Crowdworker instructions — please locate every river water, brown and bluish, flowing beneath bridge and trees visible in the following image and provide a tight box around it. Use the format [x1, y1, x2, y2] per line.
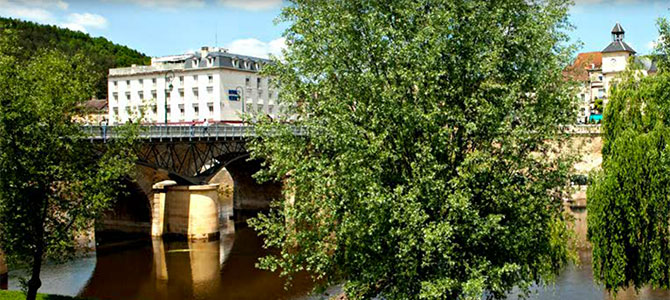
[3, 225, 670, 300]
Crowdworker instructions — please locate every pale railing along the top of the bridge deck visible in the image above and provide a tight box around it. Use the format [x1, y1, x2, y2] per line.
[82, 124, 306, 140]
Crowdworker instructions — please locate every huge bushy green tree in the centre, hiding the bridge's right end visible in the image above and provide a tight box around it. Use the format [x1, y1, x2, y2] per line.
[250, 0, 576, 299]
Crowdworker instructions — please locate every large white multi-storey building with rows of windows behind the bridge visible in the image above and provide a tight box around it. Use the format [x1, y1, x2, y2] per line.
[108, 47, 279, 124]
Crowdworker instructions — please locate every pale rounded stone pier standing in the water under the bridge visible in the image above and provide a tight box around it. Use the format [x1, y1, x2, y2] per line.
[151, 181, 219, 239]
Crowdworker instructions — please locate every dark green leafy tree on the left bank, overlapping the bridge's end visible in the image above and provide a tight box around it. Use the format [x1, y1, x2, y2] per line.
[0, 35, 137, 299]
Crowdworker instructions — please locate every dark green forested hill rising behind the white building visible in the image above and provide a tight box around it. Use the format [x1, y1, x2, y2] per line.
[0, 17, 151, 100]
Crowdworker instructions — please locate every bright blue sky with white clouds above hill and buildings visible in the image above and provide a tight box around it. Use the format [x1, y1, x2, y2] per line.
[0, 0, 670, 57]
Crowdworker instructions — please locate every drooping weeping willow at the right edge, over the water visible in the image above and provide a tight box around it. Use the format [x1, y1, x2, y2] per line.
[587, 20, 670, 293]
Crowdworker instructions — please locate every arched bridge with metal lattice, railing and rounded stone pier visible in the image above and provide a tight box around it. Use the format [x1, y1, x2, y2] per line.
[84, 124, 302, 243]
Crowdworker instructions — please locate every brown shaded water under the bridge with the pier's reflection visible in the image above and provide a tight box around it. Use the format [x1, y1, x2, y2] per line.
[75, 227, 311, 299]
